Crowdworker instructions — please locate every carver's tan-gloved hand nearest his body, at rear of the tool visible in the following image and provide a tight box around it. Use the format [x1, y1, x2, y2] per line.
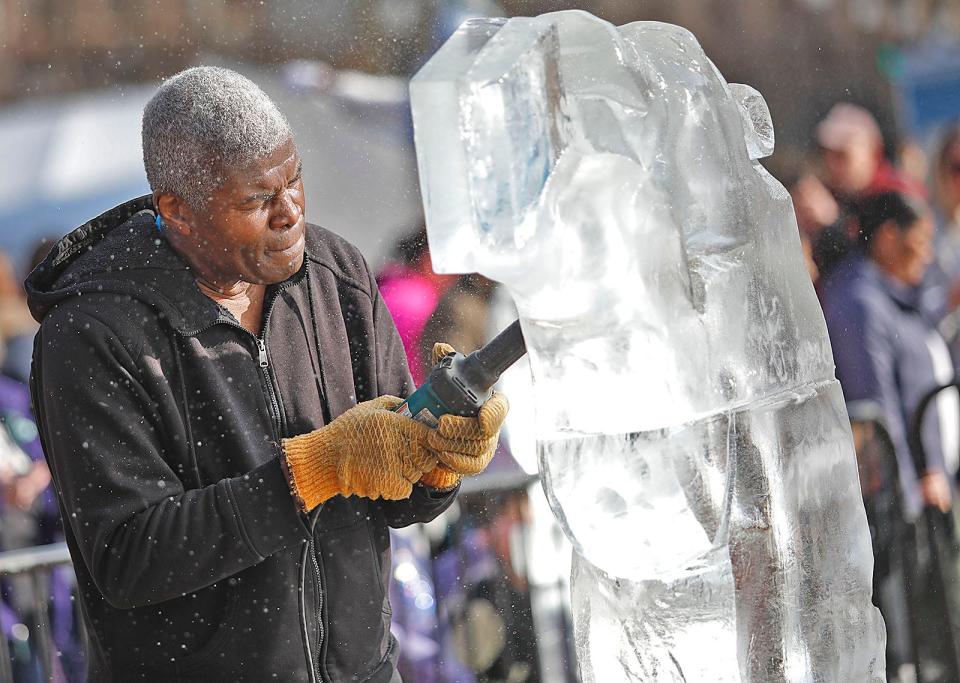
[283, 396, 437, 512]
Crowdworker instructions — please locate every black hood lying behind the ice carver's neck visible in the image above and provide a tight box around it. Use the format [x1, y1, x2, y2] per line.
[24, 195, 220, 333]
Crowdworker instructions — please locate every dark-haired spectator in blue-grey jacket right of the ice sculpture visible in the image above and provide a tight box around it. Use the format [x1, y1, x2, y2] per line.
[823, 193, 958, 518]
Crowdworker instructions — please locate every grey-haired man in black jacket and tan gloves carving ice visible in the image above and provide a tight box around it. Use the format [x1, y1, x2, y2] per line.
[27, 67, 506, 683]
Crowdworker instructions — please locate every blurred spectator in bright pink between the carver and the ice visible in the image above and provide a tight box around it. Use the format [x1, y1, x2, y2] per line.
[377, 224, 456, 385]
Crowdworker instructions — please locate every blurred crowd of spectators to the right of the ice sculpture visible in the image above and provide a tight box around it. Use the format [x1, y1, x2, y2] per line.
[790, 103, 960, 682]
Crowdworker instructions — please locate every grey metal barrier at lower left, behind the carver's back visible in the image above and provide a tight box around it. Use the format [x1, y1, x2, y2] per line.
[0, 543, 70, 683]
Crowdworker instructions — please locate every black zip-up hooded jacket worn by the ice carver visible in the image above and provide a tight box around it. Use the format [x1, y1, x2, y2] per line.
[27, 197, 454, 683]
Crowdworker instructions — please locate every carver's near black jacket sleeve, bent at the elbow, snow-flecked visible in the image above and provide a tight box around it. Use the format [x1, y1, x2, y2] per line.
[31, 306, 309, 608]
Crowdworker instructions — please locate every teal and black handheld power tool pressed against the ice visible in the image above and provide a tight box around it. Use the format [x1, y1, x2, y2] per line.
[396, 320, 527, 428]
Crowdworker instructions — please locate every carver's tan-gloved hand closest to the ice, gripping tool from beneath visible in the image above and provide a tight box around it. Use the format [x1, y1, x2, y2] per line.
[420, 343, 510, 489]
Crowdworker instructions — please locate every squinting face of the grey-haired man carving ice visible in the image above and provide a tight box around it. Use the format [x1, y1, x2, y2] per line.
[178, 140, 305, 287]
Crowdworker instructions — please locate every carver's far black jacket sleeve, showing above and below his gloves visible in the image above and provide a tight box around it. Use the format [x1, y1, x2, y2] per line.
[370, 270, 460, 528]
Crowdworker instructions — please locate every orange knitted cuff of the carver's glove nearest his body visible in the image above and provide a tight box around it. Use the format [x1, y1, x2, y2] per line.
[283, 429, 340, 512]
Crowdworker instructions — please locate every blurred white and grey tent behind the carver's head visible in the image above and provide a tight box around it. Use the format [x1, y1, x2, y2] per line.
[0, 58, 422, 267]
